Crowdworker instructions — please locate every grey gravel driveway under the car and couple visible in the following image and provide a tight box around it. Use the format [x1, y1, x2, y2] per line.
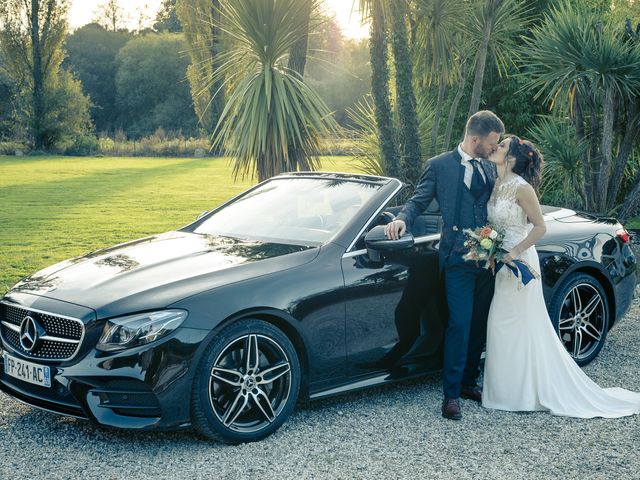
[0, 289, 640, 479]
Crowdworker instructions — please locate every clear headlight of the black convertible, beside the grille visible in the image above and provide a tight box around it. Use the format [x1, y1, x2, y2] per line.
[96, 310, 188, 352]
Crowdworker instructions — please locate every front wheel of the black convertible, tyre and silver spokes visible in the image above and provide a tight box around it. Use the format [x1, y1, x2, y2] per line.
[191, 319, 300, 444]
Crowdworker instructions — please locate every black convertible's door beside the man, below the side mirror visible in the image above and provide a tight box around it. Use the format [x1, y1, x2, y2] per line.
[342, 201, 444, 377]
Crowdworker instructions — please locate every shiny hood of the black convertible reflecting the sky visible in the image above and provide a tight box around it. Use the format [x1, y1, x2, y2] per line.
[6, 231, 319, 318]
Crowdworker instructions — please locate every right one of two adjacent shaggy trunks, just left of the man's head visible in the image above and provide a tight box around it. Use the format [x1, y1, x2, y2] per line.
[391, 2, 422, 185]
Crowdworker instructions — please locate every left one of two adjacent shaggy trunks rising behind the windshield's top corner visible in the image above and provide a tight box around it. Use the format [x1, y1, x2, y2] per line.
[369, 0, 400, 177]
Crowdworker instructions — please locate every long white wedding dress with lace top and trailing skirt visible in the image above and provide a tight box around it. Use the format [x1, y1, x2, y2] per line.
[482, 176, 640, 418]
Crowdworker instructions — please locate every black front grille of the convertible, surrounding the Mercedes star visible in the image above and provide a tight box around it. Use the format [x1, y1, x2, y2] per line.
[0, 303, 84, 360]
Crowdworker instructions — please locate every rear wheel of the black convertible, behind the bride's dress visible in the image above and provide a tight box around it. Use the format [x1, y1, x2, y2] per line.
[549, 273, 609, 366]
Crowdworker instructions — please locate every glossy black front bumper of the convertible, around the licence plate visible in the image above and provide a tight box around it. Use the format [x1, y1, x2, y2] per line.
[0, 328, 209, 430]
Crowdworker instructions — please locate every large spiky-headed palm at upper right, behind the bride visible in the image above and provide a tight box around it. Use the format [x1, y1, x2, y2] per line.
[523, 1, 640, 213]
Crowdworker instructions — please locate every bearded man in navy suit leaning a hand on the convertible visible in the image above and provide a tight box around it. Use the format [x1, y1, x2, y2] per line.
[385, 110, 504, 420]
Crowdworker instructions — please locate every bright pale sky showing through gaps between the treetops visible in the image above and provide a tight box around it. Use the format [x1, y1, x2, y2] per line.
[69, 0, 369, 38]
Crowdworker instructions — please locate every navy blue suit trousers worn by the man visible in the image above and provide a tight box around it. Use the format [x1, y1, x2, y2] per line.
[442, 259, 495, 398]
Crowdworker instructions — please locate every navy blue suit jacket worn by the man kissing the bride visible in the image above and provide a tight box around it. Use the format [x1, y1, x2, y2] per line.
[397, 149, 496, 266]
